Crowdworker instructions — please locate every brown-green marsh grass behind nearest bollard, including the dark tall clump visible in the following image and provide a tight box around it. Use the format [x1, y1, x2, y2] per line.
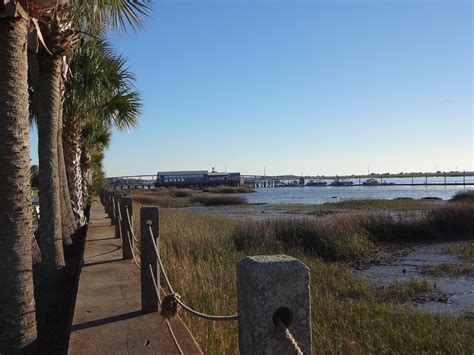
[124, 199, 474, 354]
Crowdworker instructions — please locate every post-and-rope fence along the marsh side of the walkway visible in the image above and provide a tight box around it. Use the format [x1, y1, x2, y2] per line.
[100, 189, 312, 354]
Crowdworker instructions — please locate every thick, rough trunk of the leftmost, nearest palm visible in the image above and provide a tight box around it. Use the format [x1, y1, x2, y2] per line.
[0, 17, 36, 353]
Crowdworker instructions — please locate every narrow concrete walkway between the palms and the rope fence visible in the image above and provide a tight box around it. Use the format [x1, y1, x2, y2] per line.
[69, 202, 202, 355]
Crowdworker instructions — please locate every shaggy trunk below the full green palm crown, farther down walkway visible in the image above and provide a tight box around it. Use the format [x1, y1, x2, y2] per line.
[63, 118, 86, 227]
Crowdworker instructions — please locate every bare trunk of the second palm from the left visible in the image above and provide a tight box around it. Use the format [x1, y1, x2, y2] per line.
[35, 53, 65, 273]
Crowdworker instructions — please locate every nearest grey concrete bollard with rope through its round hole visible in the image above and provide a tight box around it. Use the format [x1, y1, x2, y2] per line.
[237, 255, 311, 355]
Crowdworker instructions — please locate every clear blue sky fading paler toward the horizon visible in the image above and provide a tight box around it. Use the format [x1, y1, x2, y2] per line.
[32, 0, 474, 176]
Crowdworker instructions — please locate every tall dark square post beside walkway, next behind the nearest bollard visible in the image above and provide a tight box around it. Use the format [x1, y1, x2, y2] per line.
[140, 207, 160, 312]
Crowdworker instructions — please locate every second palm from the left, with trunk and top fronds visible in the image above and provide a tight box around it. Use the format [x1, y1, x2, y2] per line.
[35, 0, 147, 272]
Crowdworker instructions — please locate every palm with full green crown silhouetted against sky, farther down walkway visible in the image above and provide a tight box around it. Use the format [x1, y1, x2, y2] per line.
[63, 38, 141, 216]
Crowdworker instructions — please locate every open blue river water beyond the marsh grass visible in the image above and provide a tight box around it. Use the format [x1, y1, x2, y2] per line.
[245, 185, 474, 205]
